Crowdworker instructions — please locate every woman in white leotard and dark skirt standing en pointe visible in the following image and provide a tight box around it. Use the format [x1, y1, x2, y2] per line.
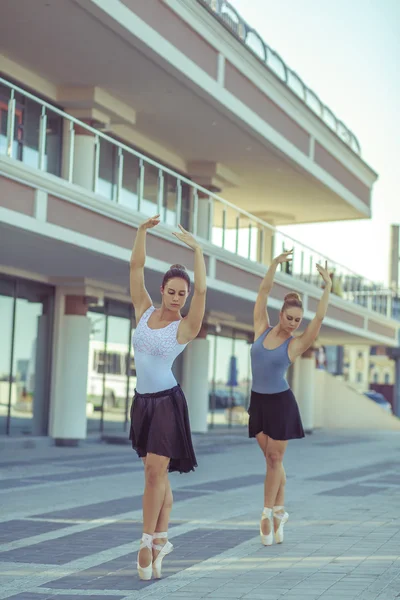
[130, 215, 206, 580]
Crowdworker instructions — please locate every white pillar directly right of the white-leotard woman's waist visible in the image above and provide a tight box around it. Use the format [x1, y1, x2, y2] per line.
[182, 338, 209, 433]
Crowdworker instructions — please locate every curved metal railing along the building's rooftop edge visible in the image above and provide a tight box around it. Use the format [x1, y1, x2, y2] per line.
[198, 0, 361, 155]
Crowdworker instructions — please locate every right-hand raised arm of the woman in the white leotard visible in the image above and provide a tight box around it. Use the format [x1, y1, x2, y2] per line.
[174, 225, 207, 344]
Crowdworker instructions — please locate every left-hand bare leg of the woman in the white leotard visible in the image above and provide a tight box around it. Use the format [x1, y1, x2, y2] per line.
[139, 453, 170, 567]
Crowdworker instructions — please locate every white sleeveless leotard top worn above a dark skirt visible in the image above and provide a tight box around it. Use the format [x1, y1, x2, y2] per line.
[132, 306, 187, 394]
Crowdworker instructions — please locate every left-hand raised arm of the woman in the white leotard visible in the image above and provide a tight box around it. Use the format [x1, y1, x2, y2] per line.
[130, 215, 160, 323]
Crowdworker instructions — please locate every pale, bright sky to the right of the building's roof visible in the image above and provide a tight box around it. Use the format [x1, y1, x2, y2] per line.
[230, 0, 400, 284]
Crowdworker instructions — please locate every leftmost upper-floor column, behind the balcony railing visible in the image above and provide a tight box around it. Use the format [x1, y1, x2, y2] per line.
[62, 120, 95, 191]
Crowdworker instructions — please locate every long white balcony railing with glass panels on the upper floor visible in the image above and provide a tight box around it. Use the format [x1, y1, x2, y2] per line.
[0, 78, 399, 317]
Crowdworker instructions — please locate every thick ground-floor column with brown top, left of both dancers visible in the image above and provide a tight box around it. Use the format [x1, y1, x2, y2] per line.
[49, 296, 90, 446]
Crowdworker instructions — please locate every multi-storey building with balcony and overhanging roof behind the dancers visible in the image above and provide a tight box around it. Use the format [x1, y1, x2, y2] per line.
[0, 0, 400, 443]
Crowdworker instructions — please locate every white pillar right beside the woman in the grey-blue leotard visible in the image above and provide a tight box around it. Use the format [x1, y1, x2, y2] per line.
[294, 355, 315, 433]
